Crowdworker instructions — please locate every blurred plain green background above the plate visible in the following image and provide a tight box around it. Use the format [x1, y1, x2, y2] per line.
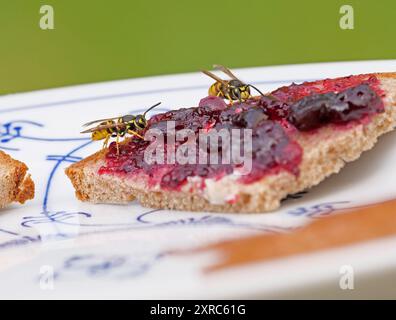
[0, 0, 396, 94]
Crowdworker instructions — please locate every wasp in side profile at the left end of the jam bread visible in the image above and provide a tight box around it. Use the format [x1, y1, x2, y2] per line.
[81, 102, 161, 154]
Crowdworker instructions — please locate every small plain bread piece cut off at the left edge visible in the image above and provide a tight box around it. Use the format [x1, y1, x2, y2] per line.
[0, 151, 34, 208]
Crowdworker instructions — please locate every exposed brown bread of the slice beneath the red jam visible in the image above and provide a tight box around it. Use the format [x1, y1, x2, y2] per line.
[66, 73, 396, 212]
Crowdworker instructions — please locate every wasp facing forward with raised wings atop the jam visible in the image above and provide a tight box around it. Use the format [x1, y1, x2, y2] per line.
[202, 64, 264, 104]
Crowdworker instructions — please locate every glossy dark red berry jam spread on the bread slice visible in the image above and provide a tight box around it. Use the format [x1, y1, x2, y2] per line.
[99, 75, 384, 190]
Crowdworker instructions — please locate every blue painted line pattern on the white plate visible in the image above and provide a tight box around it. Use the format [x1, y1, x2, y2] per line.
[0, 75, 348, 255]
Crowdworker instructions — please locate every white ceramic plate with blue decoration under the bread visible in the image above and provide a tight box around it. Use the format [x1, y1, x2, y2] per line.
[0, 60, 396, 299]
